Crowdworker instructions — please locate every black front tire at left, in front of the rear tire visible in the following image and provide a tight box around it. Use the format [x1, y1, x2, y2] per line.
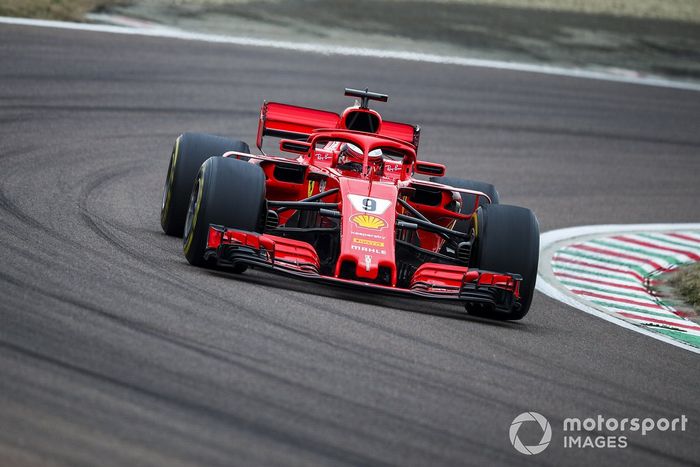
[183, 157, 265, 272]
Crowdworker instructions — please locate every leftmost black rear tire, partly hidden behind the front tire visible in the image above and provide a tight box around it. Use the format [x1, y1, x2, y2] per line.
[160, 133, 250, 237]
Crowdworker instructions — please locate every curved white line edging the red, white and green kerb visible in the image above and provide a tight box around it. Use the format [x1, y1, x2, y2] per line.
[537, 224, 700, 354]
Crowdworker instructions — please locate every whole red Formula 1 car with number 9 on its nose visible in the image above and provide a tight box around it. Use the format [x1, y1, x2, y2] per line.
[161, 89, 539, 319]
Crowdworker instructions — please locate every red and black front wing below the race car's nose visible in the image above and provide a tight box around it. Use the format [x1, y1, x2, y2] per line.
[204, 225, 522, 312]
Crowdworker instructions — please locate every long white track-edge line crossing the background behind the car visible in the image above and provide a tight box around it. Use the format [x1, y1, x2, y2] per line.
[0, 16, 700, 91]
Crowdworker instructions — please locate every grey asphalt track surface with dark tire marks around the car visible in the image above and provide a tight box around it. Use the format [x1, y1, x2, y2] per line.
[0, 25, 700, 466]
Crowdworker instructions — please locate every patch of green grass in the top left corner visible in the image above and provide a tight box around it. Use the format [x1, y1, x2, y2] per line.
[0, 0, 128, 21]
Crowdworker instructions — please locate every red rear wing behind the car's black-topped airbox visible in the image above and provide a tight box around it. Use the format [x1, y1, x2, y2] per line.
[256, 102, 420, 151]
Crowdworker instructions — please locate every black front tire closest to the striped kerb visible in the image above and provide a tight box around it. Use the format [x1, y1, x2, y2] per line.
[467, 204, 540, 320]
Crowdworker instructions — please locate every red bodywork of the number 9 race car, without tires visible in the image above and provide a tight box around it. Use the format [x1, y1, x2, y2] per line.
[205, 96, 520, 309]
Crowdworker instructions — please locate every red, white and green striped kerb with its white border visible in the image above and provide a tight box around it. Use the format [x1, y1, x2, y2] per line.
[537, 224, 700, 353]
